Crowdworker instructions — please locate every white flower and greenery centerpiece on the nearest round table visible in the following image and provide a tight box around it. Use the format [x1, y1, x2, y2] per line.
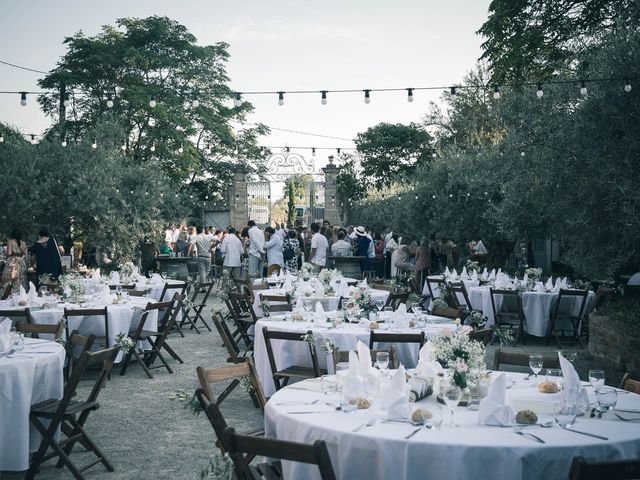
[430, 332, 486, 390]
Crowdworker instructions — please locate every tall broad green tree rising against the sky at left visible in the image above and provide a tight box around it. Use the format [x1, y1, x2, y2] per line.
[39, 16, 268, 193]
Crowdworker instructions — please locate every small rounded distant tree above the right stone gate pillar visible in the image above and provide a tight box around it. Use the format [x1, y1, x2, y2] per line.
[355, 123, 433, 187]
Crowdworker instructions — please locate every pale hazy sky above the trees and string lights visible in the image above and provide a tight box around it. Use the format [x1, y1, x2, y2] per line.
[0, 0, 490, 170]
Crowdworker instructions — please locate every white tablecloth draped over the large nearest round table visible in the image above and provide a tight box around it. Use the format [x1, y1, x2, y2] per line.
[265, 375, 640, 480]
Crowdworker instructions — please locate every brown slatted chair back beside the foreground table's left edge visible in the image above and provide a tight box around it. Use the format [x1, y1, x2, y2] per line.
[196, 358, 267, 410]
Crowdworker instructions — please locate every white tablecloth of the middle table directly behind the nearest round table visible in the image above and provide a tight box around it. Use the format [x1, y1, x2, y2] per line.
[253, 316, 455, 397]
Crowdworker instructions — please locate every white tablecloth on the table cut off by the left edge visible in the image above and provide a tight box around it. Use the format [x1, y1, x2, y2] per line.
[0, 338, 65, 471]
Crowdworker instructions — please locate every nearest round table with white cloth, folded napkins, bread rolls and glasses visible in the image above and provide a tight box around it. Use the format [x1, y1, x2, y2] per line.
[265, 343, 640, 480]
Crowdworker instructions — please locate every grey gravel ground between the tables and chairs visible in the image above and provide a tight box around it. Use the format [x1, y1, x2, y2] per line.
[0, 300, 623, 480]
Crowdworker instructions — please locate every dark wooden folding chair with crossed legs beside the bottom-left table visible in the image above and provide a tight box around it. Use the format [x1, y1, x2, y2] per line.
[25, 348, 118, 480]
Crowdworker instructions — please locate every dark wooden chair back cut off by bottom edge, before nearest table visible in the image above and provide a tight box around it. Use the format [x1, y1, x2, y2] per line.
[223, 427, 336, 480]
